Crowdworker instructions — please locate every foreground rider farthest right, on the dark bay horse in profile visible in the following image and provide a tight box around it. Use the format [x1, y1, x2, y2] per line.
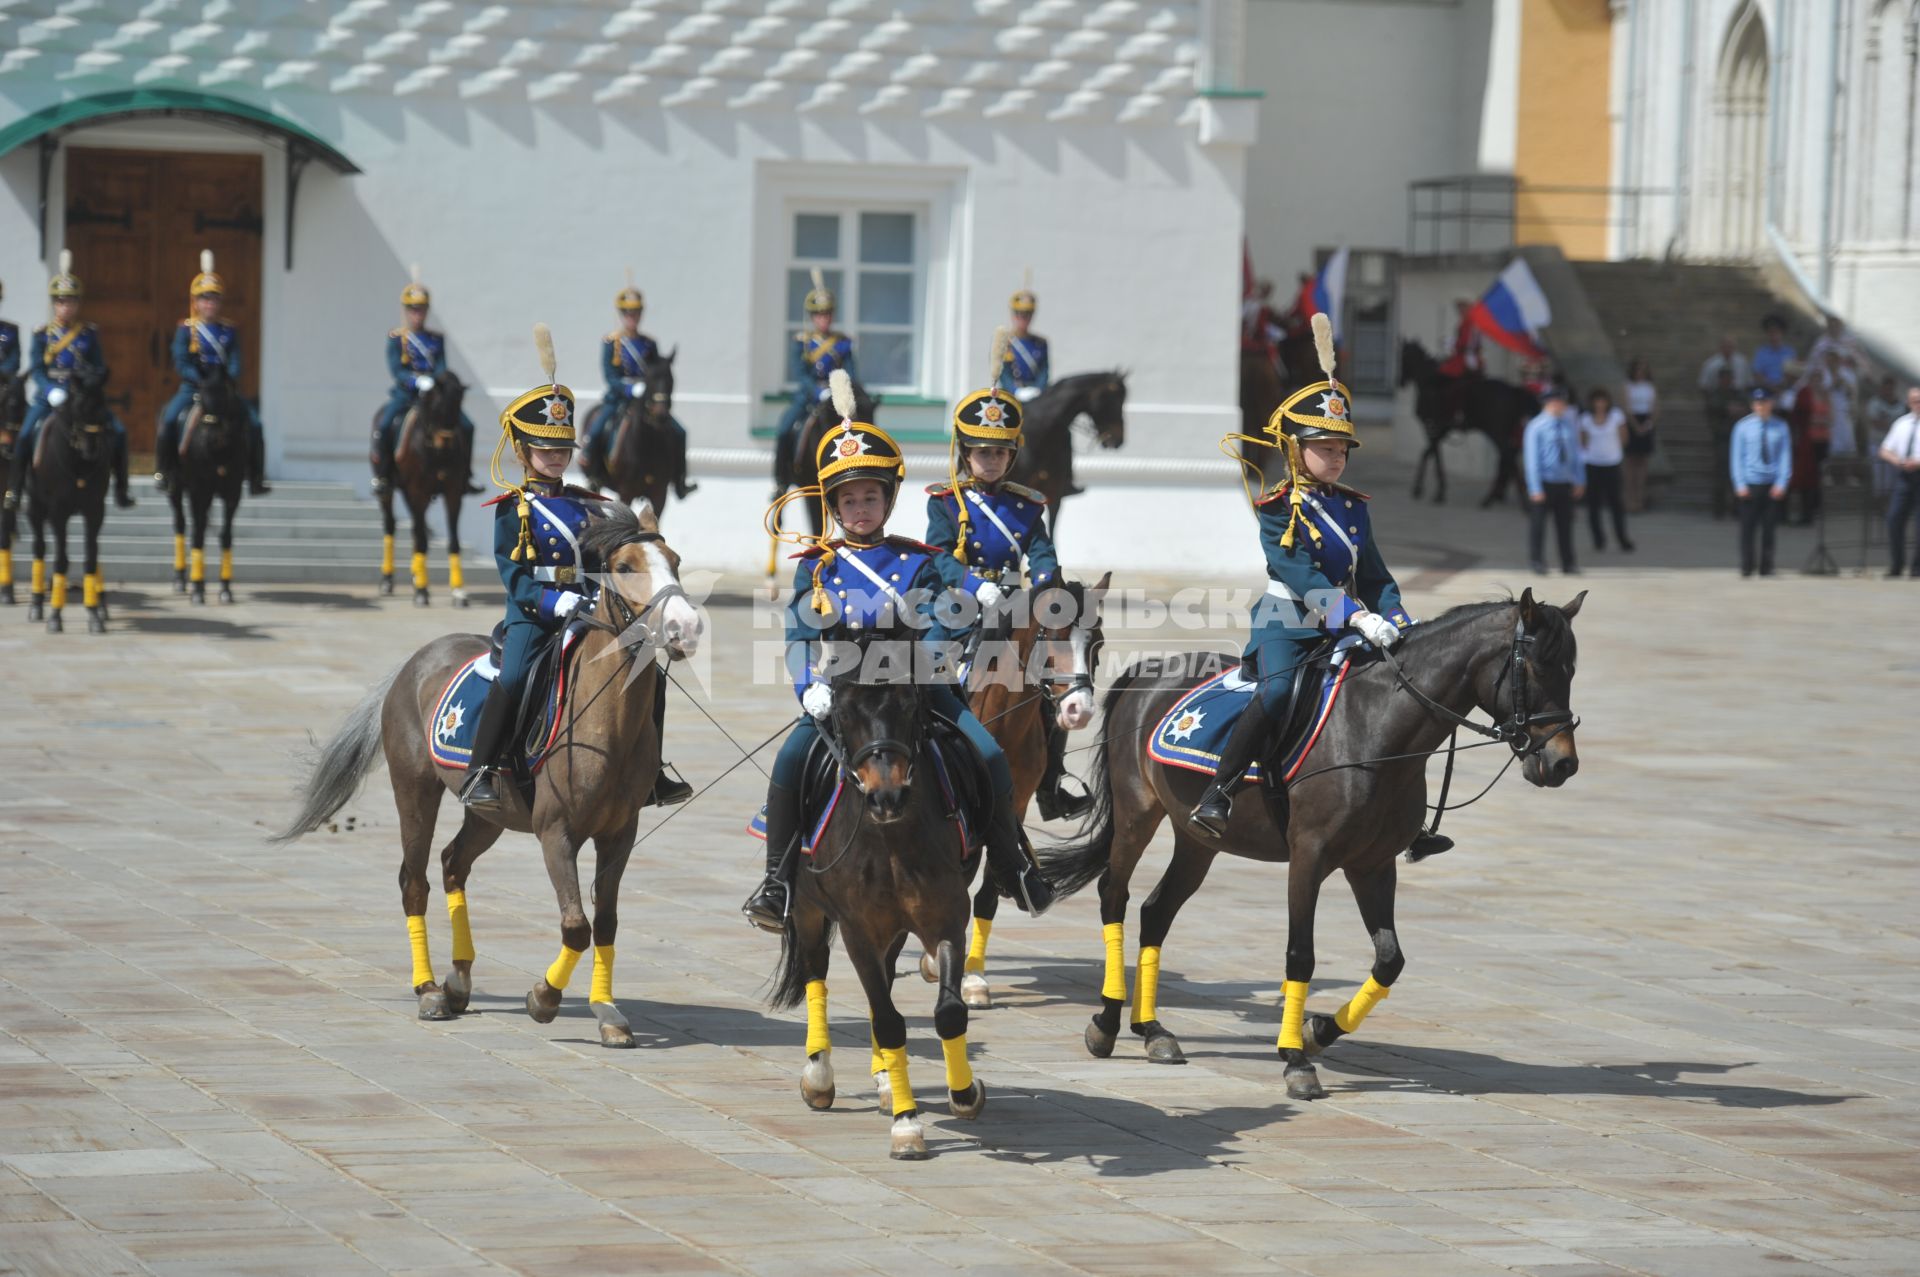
[1188, 315, 1453, 858]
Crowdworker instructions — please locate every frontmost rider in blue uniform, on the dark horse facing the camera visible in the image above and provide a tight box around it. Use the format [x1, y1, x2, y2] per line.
[741, 371, 1052, 931]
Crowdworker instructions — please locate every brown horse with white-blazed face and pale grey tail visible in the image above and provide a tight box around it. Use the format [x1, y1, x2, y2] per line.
[273, 503, 703, 1047]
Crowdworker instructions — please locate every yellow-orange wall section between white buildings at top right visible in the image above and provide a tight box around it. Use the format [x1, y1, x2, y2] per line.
[1513, 0, 1613, 261]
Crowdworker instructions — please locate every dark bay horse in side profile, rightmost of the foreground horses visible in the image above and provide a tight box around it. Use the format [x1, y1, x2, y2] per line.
[1039, 590, 1586, 1100]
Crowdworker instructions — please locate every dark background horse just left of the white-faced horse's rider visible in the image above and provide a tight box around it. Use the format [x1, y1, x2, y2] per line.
[380, 373, 472, 607]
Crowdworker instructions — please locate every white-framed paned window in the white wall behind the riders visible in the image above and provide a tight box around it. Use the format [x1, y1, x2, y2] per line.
[781, 202, 927, 394]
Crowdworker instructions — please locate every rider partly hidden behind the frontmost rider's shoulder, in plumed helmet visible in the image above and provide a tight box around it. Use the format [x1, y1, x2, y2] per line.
[927, 330, 1091, 820]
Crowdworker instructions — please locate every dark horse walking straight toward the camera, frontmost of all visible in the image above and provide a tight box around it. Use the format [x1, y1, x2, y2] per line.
[768, 622, 987, 1160]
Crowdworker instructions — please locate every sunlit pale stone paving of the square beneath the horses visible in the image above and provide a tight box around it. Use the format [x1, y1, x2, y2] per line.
[0, 480, 1920, 1277]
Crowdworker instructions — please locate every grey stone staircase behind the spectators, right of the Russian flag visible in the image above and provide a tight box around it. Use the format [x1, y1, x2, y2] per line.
[1571, 261, 1820, 509]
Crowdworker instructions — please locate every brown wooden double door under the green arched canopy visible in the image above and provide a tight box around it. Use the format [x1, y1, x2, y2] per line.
[65, 146, 265, 453]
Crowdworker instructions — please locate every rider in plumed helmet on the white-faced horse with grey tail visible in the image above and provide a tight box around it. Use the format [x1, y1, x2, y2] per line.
[459, 325, 693, 810]
